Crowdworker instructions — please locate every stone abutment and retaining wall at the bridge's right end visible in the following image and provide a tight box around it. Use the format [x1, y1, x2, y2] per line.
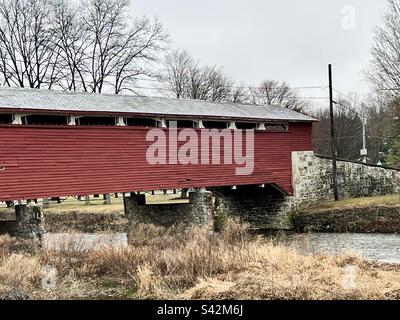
[213, 152, 400, 230]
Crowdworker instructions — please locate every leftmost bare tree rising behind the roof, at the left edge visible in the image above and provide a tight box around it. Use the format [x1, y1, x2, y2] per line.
[0, 0, 60, 88]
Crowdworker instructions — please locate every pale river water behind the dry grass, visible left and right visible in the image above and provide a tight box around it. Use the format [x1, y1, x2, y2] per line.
[45, 233, 400, 264]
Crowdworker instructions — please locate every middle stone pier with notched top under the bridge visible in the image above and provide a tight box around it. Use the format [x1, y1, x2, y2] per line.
[124, 190, 213, 227]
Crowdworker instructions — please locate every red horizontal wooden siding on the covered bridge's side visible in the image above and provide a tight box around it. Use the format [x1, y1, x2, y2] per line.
[0, 126, 311, 201]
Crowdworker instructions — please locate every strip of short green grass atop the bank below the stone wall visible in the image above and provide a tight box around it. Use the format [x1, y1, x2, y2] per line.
[307, 194, 400, 212]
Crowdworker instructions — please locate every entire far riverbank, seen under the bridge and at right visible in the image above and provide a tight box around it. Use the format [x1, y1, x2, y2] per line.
[44, 195, 400, 233]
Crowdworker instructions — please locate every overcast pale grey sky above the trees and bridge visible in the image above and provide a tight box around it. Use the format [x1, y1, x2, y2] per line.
[133, 0, 386, 105]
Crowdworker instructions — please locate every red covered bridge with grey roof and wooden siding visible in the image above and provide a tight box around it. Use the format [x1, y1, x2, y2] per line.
[0, 88, 314, 201]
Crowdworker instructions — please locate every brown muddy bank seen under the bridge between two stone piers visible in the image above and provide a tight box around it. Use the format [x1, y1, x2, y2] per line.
[45, 212, 127, 233]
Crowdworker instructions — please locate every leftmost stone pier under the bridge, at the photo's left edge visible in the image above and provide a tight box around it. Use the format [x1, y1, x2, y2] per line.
[0, 204, 46, 241]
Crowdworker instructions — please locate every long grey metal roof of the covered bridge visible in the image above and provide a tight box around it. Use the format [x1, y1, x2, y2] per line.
[0, 87, 316, 122]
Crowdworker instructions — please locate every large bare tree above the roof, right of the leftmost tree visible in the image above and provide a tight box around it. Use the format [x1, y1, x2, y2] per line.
[66, 0, 168, 94]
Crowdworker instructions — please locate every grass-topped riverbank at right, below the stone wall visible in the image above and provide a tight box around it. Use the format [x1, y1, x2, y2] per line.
[293, 195, 400, 233]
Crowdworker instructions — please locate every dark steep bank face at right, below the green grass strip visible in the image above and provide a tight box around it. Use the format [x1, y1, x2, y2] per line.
[293, 205, 400, 233]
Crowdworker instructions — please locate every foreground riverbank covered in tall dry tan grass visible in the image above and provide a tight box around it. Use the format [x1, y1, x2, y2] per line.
[0, 221, 400, 299]
